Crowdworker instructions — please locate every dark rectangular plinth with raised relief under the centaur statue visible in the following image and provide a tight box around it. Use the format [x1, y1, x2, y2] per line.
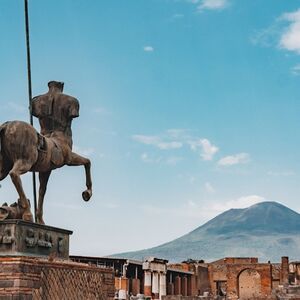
[0, 220, 73, 259]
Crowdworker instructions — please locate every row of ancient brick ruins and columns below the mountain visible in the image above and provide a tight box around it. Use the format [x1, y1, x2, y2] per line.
[71, 256, 300, 300]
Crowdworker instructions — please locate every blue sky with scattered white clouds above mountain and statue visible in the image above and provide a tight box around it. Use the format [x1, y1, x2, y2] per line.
[0, 0, 300, 255]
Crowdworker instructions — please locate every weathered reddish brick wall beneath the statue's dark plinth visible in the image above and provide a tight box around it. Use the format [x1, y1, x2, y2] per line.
[0, 257, 114, 300]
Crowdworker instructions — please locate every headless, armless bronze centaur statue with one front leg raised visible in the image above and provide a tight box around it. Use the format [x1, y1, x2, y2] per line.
[0, 81, 92, 224]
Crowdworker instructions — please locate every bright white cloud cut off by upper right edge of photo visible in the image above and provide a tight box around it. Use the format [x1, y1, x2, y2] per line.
[279, 9, 300, 54]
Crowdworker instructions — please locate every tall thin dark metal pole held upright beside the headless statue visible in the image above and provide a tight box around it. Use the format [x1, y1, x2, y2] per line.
[24, 0, 37, 222]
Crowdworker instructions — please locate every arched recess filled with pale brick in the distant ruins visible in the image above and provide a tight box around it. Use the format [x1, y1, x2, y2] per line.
[238, 269, 261, 300]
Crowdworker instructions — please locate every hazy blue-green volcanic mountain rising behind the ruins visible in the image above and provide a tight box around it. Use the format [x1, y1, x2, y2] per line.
[113, 202, 300, 262]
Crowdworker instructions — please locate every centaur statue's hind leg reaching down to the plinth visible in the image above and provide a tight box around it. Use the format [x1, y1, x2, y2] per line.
[9, 160, 33, 222]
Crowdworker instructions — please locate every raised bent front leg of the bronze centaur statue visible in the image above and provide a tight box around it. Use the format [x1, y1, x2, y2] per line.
[67, 152, 92, 201]
